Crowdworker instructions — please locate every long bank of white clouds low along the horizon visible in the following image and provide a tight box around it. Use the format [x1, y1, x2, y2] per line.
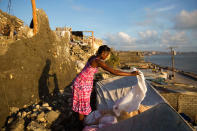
[104, 30, 192, 51]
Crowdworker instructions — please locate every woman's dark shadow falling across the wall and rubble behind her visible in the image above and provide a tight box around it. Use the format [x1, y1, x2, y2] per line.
[38, 59, 83, 131]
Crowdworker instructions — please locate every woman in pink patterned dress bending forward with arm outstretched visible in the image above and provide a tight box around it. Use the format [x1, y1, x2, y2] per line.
[72, 45, 138, 120]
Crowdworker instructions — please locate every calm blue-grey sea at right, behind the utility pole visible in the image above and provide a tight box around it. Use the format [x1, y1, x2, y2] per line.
[145, 53, 197, 74]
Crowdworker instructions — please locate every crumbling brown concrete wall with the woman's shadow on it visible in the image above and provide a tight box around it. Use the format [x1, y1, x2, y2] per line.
[0, 10, 76, 126]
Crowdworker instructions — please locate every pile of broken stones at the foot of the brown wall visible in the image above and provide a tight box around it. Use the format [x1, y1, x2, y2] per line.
[2, 88, 83, 131]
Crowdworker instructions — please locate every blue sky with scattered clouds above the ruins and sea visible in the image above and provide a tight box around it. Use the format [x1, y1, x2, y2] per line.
[0, 0, 197, 52]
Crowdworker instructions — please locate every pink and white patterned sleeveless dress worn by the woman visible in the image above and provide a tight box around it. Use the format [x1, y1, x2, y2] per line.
[72, 59, 98, 115]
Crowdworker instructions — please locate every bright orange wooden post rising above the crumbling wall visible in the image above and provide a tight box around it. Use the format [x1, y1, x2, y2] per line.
[31, 0, 38, 35]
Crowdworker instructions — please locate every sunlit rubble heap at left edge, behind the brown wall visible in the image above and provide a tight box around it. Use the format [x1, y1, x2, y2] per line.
[0, 10, 33, 55]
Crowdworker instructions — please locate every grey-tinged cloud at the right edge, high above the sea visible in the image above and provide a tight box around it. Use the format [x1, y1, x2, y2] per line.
[174, 10, 197, 30]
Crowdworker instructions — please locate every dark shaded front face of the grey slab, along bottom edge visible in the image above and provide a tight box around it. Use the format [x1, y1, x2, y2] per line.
[99, 103, 194, 131]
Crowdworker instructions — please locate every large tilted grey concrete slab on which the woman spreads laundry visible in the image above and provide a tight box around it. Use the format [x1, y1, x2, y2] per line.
[96, 76, 193, 131]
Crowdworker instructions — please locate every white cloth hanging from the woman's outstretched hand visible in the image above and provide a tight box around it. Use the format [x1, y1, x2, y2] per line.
[113, 68, 147, 116]
